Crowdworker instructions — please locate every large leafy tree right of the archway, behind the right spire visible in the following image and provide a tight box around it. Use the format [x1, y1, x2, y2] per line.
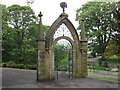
[76, 2, 119, 58]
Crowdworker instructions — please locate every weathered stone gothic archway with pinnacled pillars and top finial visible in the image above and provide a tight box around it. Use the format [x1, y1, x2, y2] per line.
[37, 2, 87, 81]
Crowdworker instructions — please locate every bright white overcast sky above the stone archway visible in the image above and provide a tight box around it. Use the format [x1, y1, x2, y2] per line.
[0, 0, 90, 28]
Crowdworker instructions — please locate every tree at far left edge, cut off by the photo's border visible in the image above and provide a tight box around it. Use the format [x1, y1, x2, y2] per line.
[0, 4, 11, 61]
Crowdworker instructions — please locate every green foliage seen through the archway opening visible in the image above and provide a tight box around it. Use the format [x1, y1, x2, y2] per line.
[54, 44, 72, 71]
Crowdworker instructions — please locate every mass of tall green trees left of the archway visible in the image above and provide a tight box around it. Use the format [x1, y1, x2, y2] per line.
[0, 5, 49, 64]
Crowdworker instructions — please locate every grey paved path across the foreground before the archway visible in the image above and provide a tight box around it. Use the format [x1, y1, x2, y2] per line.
[0, 68, 118, 88]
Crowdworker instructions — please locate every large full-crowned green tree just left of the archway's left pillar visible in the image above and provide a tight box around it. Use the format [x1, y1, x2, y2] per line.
[3, 5, 37, 63]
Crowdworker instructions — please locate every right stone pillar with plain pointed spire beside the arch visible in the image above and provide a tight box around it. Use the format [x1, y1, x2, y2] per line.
[80, 21, 88, 77]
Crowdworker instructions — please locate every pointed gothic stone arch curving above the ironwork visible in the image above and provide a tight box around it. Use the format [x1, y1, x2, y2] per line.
[46, 13, 79, 48]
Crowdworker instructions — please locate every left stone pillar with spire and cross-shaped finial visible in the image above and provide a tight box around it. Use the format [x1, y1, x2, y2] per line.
[37, 12, 46, 81]
